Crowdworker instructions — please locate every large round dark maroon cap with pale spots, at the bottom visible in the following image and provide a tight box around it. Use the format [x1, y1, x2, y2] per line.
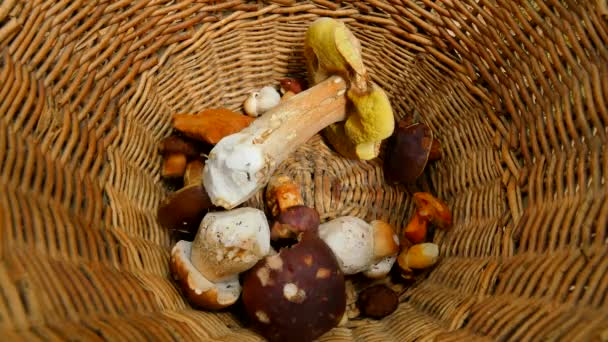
[242, 233, 346, 342]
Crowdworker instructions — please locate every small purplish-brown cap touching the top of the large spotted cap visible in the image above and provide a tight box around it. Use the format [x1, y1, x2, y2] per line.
[270, 205, 321, 240]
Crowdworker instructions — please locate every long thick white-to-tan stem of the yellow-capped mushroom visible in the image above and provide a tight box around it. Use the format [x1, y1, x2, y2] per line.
[203, 76, 347, 209]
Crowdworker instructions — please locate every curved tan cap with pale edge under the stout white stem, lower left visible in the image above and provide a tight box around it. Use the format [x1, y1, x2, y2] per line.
[169, 240, 241, 310]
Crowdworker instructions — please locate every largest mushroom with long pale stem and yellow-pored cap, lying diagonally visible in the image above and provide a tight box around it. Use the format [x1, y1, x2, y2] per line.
[203, 18, 394, 209]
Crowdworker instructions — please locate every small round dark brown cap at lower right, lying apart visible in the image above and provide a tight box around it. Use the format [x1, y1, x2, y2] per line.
[357, 284, 399, 319]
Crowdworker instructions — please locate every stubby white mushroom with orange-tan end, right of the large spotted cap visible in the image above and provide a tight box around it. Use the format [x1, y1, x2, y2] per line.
[319, 216, 399, 275]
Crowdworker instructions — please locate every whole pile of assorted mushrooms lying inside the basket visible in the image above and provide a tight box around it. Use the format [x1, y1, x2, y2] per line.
[158, 18, 451, 341]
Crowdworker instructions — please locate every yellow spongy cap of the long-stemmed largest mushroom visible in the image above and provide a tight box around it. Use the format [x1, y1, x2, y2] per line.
[304, 18, 395, 160]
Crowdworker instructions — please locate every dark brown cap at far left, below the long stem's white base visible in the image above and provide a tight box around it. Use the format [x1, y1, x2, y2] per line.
[157, 184, 213, 232]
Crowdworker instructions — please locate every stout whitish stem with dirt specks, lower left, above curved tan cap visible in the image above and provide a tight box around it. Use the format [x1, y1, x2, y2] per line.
[191, 207, 270, 282]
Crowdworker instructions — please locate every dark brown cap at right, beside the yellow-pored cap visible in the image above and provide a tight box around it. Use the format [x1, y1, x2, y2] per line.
[384, 123, 433, 183]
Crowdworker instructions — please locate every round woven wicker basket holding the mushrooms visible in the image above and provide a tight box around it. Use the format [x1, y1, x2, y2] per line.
[0, 0, 608, 341]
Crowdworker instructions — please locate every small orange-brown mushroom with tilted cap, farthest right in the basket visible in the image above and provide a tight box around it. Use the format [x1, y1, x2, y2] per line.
[403, 192, 452, 244]
